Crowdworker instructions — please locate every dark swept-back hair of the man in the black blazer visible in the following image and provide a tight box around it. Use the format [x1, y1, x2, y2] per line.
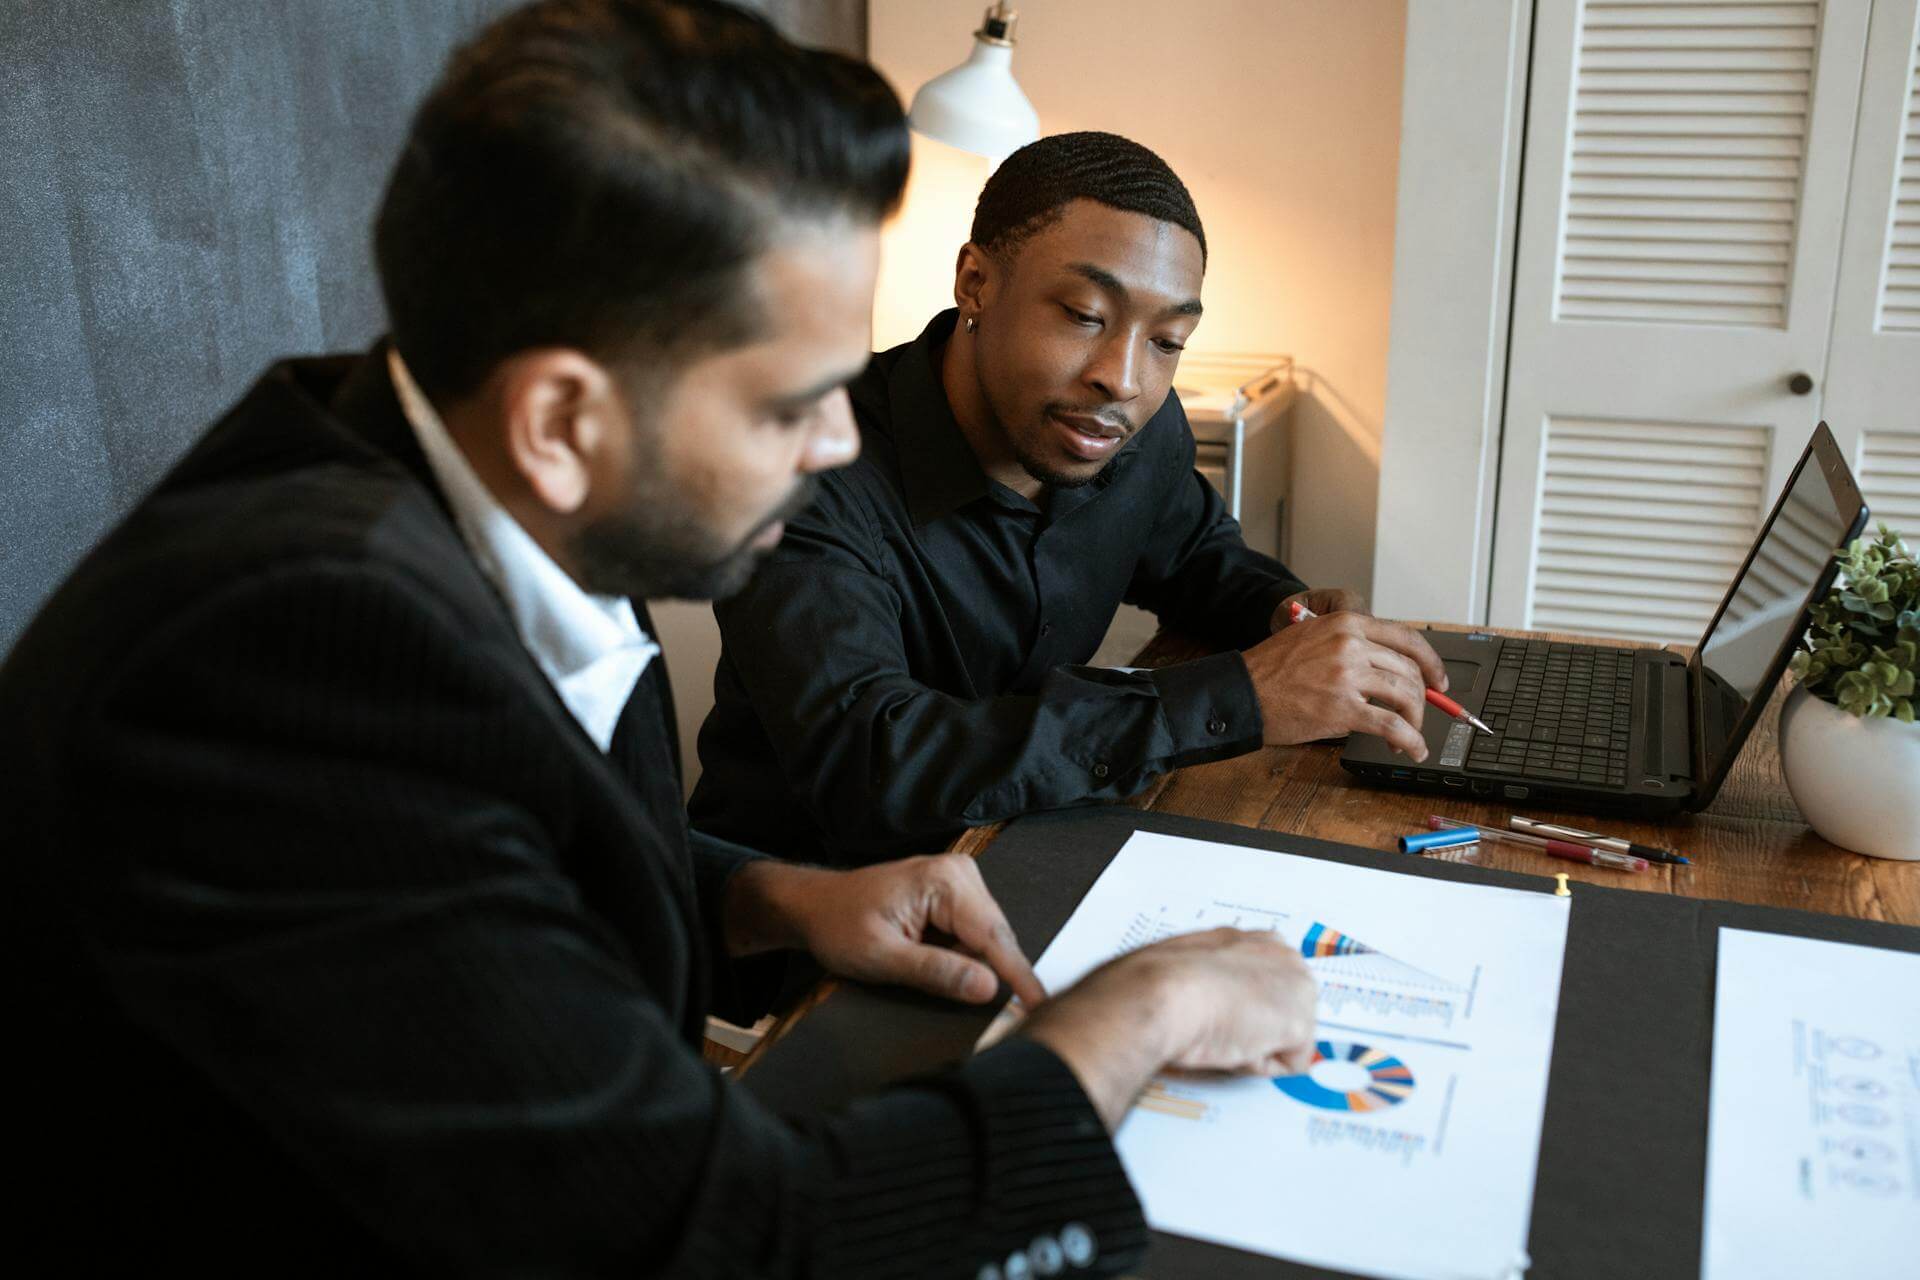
[374, 0, 908, 397]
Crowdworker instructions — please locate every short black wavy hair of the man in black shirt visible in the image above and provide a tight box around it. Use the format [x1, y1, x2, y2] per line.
[972, 132, 1206, 265]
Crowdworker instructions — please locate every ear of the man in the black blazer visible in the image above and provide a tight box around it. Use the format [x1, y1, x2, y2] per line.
[495, 347, 626, 516]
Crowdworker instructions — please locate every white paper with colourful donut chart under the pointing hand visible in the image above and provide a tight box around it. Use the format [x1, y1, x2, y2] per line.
[1037, 831, 1569, 1280]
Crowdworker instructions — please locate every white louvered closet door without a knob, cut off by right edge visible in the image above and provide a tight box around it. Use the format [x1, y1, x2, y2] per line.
[1822, 0, 1920, 547]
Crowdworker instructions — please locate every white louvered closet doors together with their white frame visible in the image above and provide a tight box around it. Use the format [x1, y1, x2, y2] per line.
[1375, 0, 1920, 641]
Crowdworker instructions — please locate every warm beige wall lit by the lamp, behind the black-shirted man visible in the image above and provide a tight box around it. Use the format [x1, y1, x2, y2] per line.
[868, 0, 1405, 589]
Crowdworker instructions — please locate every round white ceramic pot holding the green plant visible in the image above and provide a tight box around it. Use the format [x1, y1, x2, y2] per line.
[1780, 687, 1920, 860]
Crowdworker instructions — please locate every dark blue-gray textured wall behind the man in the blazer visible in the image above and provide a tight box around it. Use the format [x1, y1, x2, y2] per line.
[0, 0, 866, 656]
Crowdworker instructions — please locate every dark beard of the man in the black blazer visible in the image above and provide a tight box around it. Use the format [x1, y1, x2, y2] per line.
[572, 476, 820, 601]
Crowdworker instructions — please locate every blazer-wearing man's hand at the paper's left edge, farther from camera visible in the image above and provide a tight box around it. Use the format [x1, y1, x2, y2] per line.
[728, 854, 1046, 1007]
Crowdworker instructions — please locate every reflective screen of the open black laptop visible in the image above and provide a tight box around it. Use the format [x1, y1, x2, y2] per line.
[1693, 424, 1866, 785]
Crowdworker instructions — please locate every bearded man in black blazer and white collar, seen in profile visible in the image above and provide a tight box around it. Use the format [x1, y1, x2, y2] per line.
[0, 0, 1313, 1278]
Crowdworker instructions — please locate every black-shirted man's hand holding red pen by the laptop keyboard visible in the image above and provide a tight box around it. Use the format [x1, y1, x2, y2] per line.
[1242, 612, 1446, 760]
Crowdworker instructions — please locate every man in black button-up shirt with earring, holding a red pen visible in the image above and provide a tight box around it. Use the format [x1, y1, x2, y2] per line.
[691, 132, 1446, 865]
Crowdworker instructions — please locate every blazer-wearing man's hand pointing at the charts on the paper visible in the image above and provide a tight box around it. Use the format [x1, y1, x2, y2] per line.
[1021, 929, 1317, 1130]
